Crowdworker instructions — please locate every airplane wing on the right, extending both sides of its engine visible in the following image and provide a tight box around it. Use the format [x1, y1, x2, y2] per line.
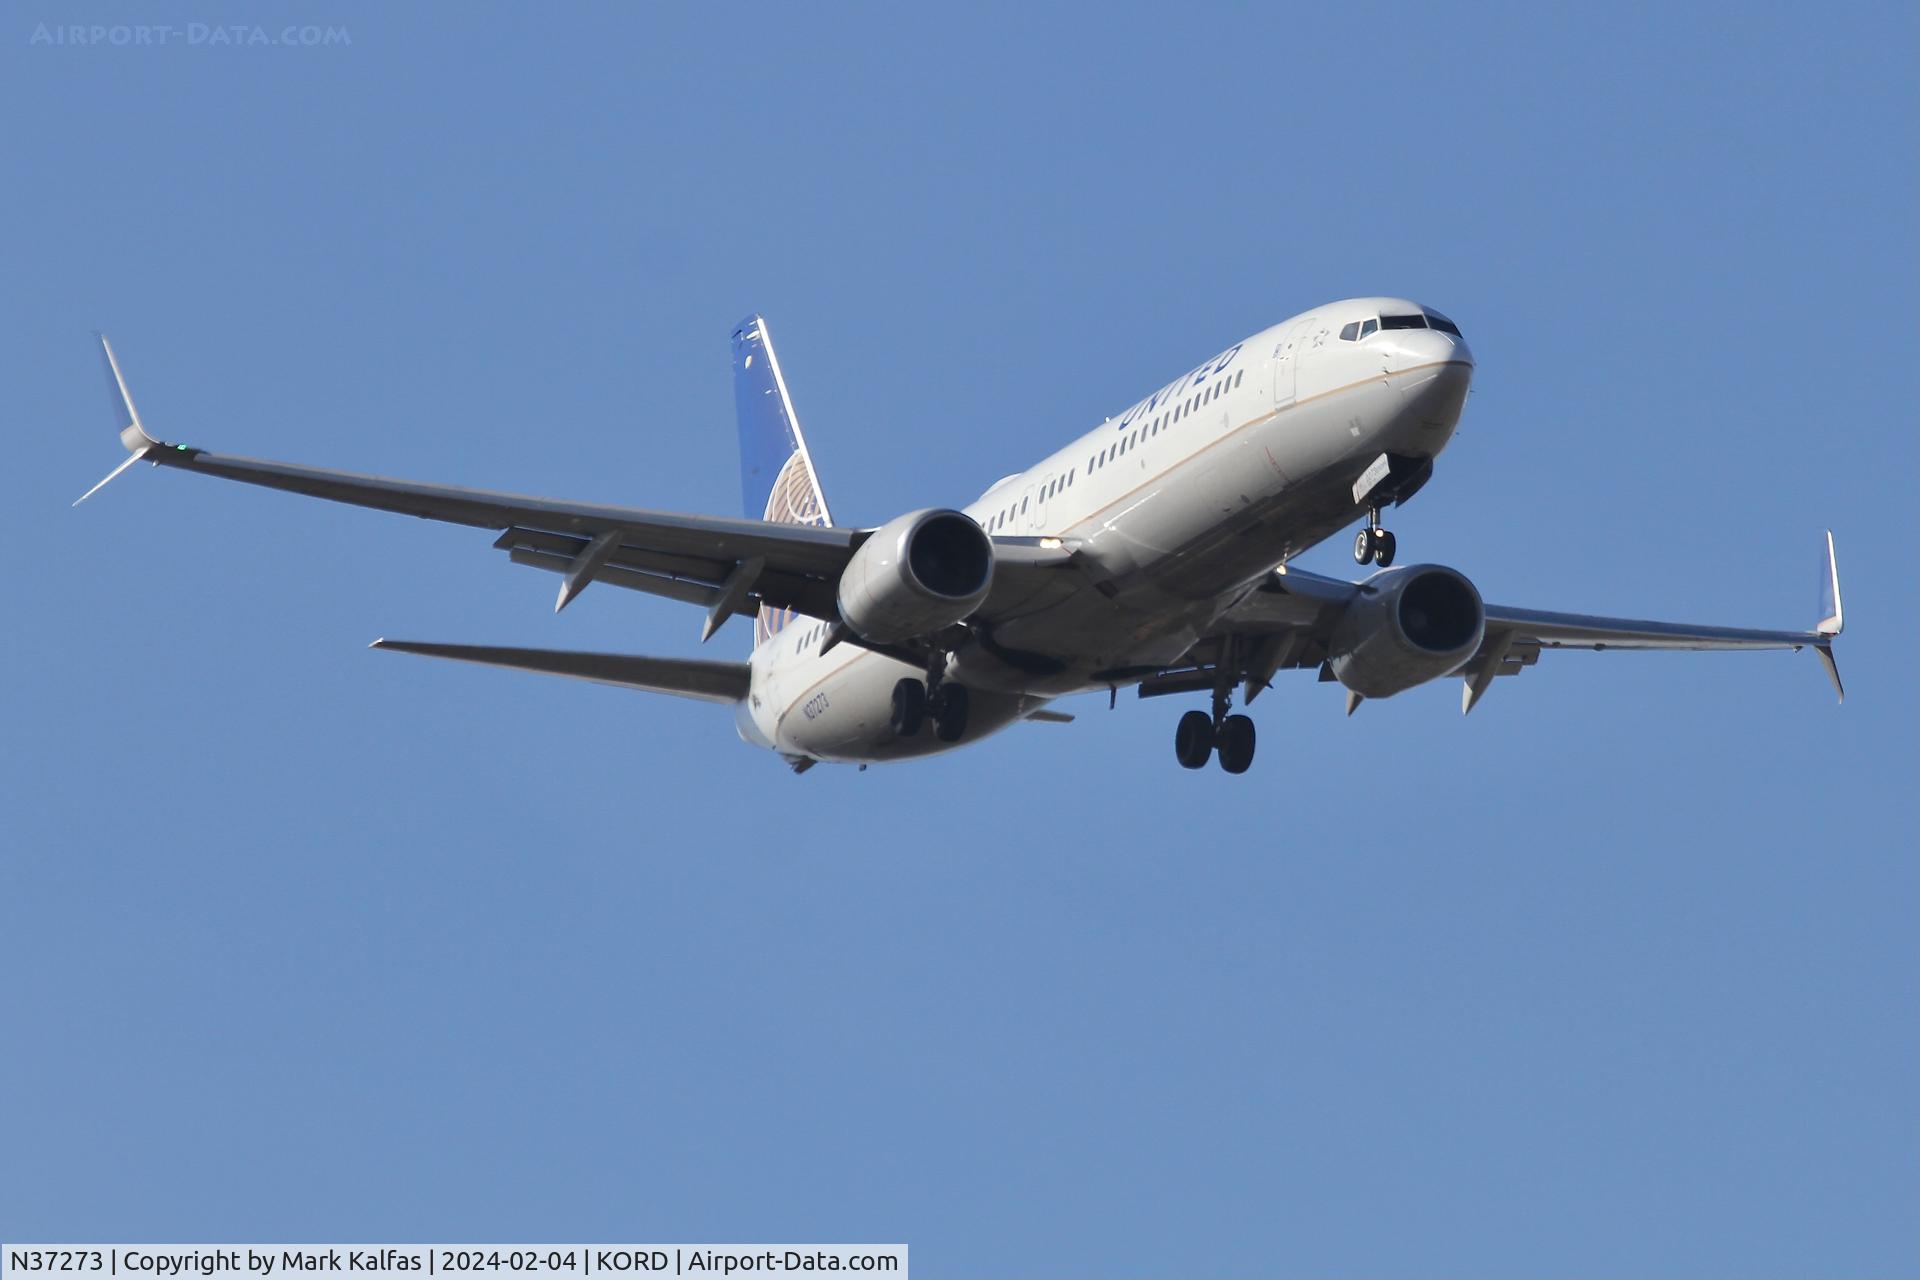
[1140, 533, 1845, 714]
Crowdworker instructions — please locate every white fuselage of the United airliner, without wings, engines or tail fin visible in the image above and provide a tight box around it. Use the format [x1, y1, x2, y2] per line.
[735, 297, 1473, 762]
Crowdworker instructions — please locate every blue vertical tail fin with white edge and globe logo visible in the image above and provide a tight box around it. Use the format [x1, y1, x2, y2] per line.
[733, 315, 833, 524]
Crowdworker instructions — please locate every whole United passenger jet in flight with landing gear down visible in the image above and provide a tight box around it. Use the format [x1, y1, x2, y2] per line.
[75, 297, 1845, 773]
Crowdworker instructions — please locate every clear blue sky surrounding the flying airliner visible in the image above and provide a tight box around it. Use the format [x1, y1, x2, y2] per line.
[0, 4, 1920, 1278]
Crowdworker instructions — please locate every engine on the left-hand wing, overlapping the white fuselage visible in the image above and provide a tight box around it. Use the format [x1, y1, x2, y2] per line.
[839, 509, 993, 645]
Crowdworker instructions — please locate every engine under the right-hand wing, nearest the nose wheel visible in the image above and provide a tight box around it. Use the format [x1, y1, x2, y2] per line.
[1327, 564, 1486, 699]
